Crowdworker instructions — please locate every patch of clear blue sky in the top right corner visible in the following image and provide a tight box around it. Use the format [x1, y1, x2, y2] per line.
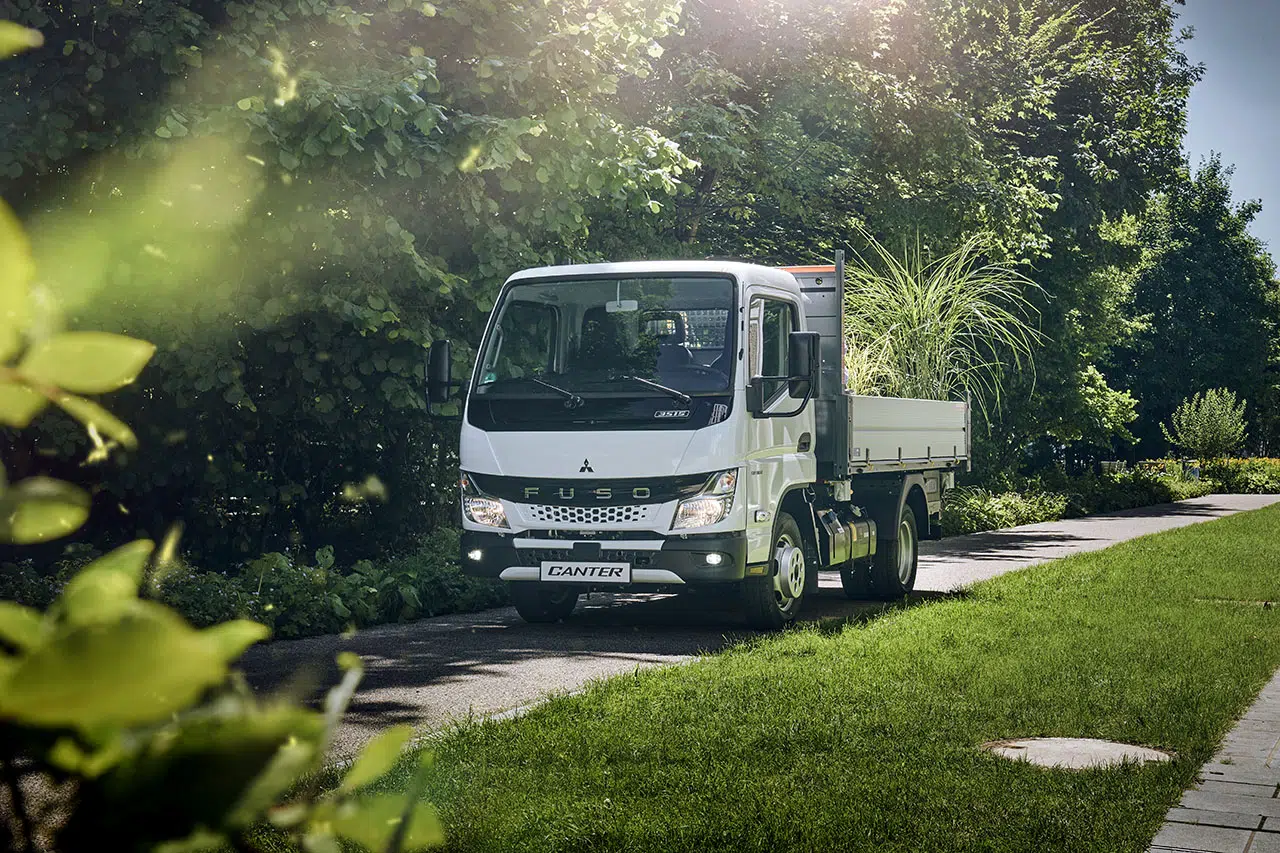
[1175, 0, 1280, 257]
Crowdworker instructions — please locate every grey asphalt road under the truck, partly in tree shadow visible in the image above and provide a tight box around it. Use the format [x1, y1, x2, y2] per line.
[243, 496, 1280, 758]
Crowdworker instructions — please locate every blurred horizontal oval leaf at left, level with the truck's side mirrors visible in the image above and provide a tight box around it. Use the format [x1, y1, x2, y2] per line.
[18, 332, 156, 394]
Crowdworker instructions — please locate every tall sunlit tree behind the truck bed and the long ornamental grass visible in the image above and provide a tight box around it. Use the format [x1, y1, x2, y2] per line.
[591, 0, 1199, 465]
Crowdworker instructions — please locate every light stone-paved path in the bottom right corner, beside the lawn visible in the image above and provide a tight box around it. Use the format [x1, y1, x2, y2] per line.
[1151, 674, 1280, 853]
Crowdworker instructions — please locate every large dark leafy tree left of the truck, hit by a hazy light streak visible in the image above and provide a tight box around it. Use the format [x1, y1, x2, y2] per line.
[0, 0, 691, 560]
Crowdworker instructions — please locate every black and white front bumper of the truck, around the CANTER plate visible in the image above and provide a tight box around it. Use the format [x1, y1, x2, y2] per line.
[460, 530, 746, 590]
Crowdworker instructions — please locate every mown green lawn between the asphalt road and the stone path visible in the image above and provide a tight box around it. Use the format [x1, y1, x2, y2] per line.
[376, 508, 1280, 852]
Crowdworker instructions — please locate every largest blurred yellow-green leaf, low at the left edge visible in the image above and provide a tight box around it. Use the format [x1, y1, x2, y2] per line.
[0, 601, 227, 733]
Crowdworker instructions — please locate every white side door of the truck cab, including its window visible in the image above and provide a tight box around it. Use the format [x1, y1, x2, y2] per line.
[746, 291, 817, 565]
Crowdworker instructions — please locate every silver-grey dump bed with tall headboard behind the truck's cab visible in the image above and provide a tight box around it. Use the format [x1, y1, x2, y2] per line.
[787, 252, 970, 480]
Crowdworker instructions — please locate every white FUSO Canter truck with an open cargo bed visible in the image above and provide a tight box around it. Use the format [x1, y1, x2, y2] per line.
[426, 254, 970, 629]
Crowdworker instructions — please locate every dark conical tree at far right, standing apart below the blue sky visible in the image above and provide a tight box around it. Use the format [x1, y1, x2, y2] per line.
[1111, 155, 1280, 456]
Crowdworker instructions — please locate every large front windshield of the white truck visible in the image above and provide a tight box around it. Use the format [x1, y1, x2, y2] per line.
[475, 277, 733, 398]
